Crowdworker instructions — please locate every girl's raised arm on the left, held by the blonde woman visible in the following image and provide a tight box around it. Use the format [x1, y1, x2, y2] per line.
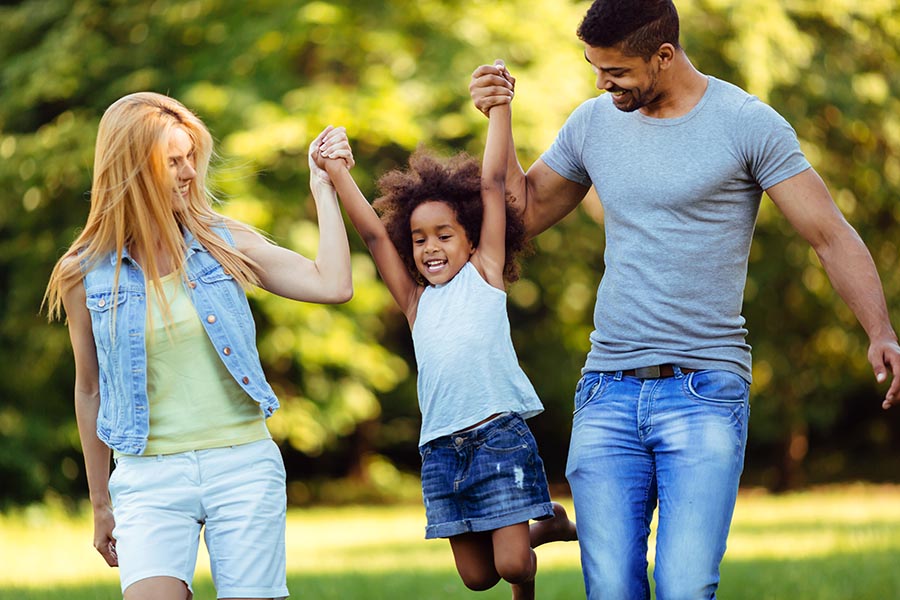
[317, 148, 424, 326]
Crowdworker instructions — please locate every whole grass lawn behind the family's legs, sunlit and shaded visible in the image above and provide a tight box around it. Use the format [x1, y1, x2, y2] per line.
[0, 485, 900, 600]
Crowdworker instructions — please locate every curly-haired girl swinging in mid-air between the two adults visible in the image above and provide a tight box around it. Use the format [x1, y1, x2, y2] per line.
[314, 63, 575, 598]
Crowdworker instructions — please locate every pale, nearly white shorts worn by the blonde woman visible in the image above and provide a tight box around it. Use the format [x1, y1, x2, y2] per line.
[109, 440, 288, 598]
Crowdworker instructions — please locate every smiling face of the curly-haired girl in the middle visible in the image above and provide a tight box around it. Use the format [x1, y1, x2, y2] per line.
[409, 200, 475, 285]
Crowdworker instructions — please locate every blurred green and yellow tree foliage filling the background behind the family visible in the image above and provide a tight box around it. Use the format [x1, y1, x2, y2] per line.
[0, 0, 900, 503]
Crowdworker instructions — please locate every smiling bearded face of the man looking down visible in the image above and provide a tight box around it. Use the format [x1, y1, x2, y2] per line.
[584, 44, 661, 112]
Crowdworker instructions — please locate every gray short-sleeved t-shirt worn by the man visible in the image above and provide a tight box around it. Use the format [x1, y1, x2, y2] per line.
[542, 77, 810, 381]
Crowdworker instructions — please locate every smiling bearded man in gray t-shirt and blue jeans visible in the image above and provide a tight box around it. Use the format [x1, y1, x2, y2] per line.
[470, 0, 900, 600]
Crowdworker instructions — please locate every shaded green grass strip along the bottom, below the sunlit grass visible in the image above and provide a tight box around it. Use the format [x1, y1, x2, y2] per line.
[0, 552, 900, 600]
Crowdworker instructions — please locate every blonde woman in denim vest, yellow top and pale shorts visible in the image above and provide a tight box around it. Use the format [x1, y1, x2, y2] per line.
[45, 92, 353, 600]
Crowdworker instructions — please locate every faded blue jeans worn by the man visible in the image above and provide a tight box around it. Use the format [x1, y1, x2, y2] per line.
[566, 367, 750, 600]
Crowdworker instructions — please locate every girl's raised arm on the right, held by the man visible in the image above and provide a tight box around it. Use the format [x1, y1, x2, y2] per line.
[472, 61, 512, 290]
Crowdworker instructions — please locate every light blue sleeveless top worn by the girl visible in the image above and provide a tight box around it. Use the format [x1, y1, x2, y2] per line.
[412, 262, 544, 446]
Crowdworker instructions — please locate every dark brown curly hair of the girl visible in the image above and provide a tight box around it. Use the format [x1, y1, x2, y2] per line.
[372, 147, 529, 285]
